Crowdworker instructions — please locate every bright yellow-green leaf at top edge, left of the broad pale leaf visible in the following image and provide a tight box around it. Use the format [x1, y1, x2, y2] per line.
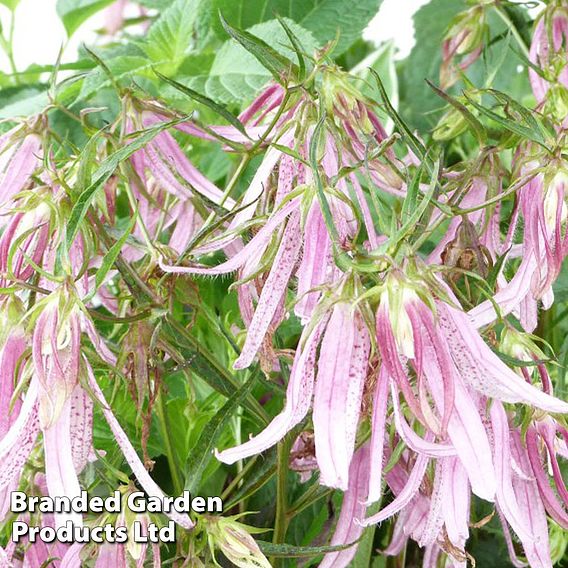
[142, 0, 201, 73]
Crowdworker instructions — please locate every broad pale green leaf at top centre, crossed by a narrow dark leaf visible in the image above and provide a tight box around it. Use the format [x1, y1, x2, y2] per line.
[205, 20, 321, 104]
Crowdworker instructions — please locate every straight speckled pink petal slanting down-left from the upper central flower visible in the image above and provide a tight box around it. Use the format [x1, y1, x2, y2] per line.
[233, 212, 302, 369]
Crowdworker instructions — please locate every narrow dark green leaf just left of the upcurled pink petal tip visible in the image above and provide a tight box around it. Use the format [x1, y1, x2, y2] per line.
[185, 375, 256, 495]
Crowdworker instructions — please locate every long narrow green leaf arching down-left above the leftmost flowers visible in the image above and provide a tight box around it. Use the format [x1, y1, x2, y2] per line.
[66, 118, 185, 248]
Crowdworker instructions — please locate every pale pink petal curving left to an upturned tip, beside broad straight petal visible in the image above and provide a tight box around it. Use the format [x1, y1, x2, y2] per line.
[216, 319, 327, 464]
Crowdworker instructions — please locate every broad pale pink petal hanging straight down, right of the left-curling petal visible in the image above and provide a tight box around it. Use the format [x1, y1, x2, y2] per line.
[313, 302, 371, 490]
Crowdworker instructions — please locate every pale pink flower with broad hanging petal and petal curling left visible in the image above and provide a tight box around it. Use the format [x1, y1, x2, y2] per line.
[217, 280, 370, 490]
